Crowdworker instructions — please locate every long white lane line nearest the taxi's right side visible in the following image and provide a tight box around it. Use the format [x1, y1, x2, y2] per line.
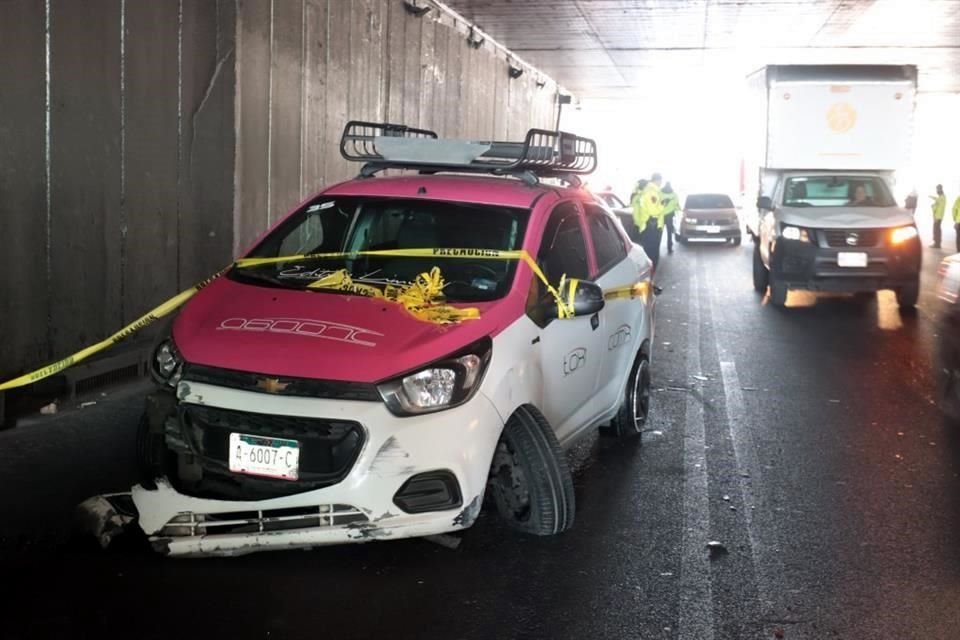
[677, 254, 713, 640]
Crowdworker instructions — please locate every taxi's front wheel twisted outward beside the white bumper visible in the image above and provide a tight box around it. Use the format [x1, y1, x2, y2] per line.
[490, 405, 576, 536]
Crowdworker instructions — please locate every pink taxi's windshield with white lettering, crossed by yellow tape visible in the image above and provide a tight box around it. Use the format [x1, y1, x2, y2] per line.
[231, 197, 529, 302]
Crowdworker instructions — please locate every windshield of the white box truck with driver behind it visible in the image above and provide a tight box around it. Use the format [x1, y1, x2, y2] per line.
[783, 176, 896, 207]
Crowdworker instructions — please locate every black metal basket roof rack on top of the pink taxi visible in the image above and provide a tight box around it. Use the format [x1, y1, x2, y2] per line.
[340, 120, 597, 183]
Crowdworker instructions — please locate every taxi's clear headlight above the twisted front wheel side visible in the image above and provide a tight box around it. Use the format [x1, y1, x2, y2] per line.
[377, 338, 492, 416]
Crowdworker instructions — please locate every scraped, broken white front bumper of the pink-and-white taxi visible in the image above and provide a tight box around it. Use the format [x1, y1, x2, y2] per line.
[132, 383, 503, 556]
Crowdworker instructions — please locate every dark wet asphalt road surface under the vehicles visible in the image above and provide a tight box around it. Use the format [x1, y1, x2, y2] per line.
[0, 236, 960, 640]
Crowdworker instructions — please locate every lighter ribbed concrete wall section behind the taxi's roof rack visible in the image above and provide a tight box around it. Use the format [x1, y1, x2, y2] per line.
[234, 0, 557, 251]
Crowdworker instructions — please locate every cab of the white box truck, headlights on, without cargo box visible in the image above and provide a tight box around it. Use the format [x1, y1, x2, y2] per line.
[753, 171, 921, 307]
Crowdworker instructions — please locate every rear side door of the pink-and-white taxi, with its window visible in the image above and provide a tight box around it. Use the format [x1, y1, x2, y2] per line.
[585, 204, 645, 411]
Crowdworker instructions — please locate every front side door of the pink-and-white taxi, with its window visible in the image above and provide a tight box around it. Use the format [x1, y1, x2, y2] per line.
[530, 202, 603, 442]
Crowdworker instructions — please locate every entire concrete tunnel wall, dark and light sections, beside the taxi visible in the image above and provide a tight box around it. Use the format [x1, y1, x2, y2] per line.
[0, 0, 557, 380]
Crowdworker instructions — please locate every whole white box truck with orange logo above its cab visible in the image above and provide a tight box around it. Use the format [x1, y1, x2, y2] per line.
[744, 65, 921, 307]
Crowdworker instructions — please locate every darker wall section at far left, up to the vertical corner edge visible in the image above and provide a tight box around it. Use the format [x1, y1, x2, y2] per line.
[0, 0, 236, 379]
